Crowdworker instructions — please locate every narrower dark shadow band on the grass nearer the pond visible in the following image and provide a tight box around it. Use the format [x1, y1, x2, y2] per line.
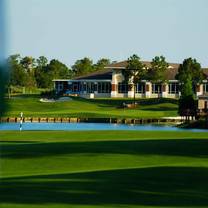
[0, 139, 208, 159]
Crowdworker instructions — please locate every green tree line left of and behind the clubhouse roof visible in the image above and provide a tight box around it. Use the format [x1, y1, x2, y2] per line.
[7, 54, 110, 89]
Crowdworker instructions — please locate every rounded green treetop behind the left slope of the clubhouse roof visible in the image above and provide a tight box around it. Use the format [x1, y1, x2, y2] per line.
[72, 58, 95, 77]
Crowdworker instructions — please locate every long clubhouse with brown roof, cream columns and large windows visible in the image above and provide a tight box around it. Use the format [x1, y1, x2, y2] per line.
[53, 61, 208, 98]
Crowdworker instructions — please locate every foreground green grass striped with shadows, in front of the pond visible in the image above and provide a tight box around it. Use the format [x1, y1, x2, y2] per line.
[0, 131, 208, 208]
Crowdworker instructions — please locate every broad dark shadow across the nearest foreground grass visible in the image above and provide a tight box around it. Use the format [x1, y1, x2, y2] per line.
[0, 167, 208, 207]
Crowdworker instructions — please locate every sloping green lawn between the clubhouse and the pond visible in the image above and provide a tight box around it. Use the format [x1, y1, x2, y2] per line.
[5, 96, 177, 118]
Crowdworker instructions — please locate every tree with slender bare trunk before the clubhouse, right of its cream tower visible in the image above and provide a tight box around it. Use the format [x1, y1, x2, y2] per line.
[123, 54, 146, 106]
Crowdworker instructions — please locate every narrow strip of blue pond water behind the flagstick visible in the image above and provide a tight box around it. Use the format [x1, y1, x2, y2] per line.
[0, 123, 208, 132]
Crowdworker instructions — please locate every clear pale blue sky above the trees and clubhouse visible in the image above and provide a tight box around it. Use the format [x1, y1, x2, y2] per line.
[6, 0, 208, 67]
